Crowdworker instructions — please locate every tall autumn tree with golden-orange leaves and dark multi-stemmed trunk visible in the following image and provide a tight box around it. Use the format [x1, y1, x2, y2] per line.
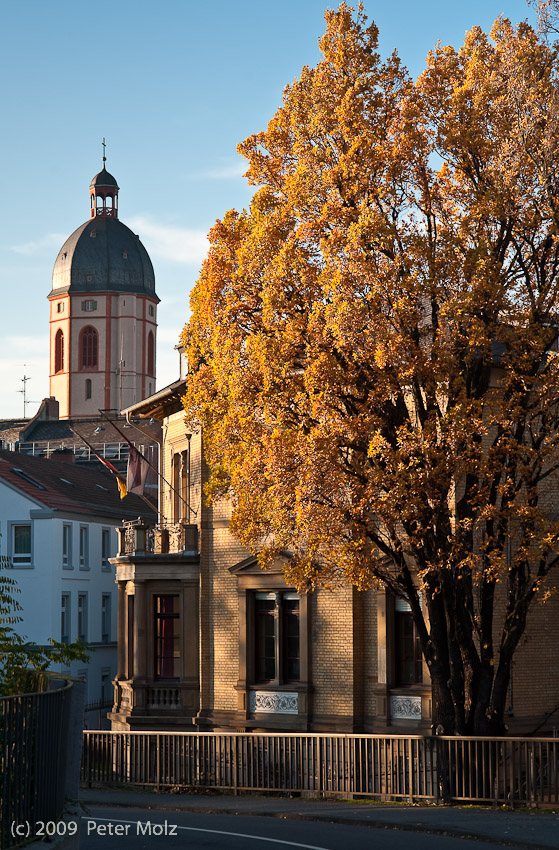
[184, 4, 559, 734]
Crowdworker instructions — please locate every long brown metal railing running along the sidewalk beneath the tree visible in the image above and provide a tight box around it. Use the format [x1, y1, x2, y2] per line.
[82, 731, 559, 806]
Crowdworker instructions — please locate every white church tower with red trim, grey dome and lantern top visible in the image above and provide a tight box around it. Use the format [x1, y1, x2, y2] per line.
[48, 156, 159, 419]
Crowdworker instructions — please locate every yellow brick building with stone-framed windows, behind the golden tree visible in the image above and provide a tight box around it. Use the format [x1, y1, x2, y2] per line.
[110, 348, 559, 734]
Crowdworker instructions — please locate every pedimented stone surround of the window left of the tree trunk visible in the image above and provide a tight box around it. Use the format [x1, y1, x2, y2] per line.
[229, 556, 312, 729]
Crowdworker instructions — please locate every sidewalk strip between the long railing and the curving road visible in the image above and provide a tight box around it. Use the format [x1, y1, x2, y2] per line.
[80, 787, 559, 850]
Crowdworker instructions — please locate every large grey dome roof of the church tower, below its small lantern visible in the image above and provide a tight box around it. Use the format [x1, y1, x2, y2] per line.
[50, 215, 159, 301]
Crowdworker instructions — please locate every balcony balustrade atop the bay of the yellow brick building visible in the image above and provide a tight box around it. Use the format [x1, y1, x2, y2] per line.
[117, 518, 198, 557]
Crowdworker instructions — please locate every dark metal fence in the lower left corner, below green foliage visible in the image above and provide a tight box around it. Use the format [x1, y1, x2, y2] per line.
[0, 685, 72, 850]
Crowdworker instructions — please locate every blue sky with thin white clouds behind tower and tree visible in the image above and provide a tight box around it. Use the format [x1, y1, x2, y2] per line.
[0, 0, 534, 418]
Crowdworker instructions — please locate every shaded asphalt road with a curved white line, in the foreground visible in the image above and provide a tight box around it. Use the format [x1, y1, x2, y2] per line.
[79, 806, 503, 850]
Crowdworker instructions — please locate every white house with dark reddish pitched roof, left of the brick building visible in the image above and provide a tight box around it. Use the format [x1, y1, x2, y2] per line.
[0, 452, 155, 705]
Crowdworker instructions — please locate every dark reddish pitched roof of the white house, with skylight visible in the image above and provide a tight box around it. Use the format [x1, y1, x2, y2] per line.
[0, 451, 156, 522]
